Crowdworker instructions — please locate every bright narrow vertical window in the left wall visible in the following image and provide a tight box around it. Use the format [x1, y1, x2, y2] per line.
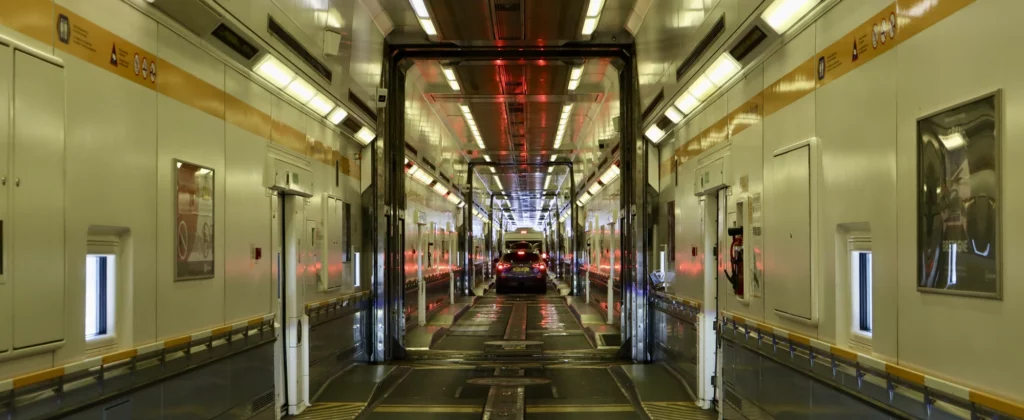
[85, 254, 117, 341]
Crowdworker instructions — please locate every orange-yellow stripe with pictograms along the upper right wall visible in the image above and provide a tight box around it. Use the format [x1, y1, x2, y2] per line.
[662, 0, 975, 176]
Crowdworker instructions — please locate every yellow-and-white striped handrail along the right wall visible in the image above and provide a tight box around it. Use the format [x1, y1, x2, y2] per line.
[653, 292, 1024, 418]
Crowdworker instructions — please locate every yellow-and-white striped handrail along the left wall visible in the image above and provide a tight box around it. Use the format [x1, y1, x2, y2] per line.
[0, 313, 276, 407]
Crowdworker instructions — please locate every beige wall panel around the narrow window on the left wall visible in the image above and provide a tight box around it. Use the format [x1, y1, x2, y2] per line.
[56, 52, 158, 362]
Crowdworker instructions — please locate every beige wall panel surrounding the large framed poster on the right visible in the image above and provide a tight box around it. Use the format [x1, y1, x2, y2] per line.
[894, 0, 1024, 395]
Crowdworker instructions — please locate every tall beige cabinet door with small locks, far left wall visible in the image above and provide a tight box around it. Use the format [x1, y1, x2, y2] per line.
[10, 51, 65, 348]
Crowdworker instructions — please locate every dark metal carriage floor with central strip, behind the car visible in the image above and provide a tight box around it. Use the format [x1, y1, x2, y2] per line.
[295, 284, 717, 420]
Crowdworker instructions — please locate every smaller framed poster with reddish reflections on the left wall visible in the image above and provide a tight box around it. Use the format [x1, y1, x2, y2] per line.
[174, 160, 215, 282]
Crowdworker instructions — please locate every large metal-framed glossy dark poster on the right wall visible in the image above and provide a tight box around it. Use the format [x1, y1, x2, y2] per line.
[916, 91, 1002, 299]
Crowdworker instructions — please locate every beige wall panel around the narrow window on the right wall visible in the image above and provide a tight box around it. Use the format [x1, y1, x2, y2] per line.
[815, 49, 897, 350]
